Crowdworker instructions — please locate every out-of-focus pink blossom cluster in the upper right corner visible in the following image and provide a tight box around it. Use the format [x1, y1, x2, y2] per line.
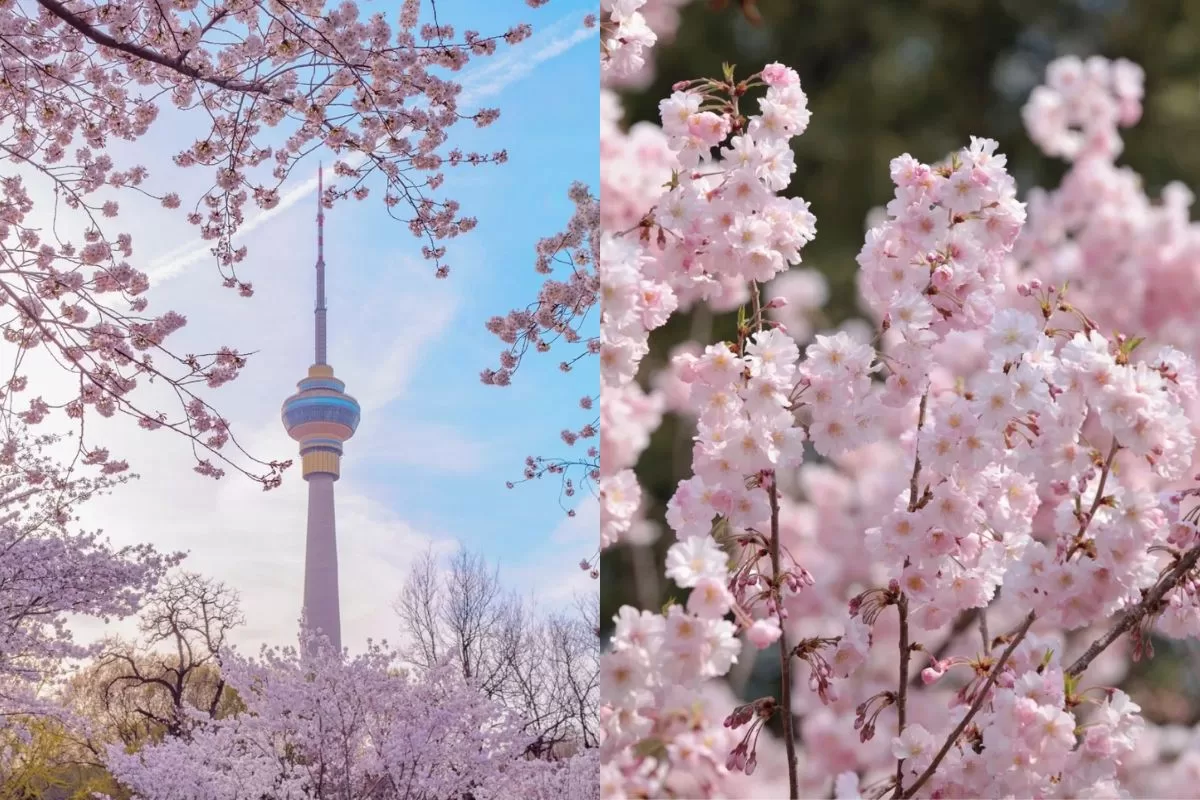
[1016, 56, 1200, 367]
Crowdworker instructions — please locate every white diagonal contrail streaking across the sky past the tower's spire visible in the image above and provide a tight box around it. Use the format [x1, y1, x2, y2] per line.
[149, 14, 596, 282]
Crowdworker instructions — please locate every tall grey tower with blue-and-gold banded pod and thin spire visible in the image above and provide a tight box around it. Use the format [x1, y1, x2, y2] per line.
[283, 169, 361, 651]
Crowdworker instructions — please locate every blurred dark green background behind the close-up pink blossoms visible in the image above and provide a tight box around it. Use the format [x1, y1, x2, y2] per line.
[601, 0, 1200, 721]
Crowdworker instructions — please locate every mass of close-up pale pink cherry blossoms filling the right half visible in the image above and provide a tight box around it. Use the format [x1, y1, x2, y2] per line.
[599, 23, 1200, 798]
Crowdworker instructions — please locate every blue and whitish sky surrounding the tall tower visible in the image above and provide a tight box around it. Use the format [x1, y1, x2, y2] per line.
[47, 0, 599, 649]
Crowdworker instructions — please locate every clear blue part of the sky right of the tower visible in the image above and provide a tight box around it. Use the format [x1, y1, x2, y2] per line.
[350, 0, 599, 560]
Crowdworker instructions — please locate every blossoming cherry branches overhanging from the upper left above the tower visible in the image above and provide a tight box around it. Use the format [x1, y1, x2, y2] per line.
[0, 0, 547, 488]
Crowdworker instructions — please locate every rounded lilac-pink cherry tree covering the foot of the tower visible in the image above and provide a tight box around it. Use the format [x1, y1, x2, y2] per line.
[108, 646, 595, 800]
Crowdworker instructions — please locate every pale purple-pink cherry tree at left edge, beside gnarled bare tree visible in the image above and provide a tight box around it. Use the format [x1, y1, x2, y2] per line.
[0, 420, 181, 796]
